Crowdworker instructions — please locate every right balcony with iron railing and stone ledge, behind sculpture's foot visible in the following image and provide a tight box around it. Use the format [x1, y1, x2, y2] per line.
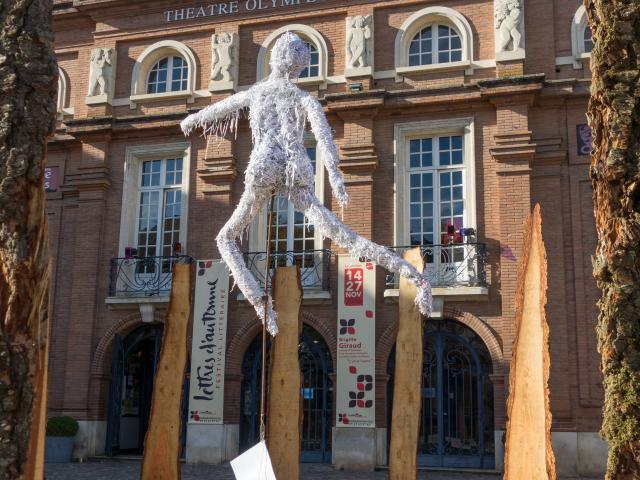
[384, 242, 488, 317]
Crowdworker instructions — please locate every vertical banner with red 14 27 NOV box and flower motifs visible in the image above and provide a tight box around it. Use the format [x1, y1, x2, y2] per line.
[336, 255, 376, 427]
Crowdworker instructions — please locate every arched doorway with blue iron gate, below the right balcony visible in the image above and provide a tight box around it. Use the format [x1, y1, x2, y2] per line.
[388, 320, 495, 469]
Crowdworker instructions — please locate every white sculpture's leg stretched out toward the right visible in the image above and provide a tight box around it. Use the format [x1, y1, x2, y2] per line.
[291, 189, 431, 316]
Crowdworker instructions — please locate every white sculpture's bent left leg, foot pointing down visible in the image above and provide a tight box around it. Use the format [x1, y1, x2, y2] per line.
[216, 186, 278, 335]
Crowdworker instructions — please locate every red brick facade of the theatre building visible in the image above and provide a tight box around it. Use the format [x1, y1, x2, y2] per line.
[47, 0, 602, 472]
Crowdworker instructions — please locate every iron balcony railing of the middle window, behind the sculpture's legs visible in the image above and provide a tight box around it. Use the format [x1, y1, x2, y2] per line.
[244, 250, 333, 291]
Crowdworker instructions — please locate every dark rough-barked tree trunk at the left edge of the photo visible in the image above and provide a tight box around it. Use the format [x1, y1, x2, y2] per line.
[0, 0, 57, 480]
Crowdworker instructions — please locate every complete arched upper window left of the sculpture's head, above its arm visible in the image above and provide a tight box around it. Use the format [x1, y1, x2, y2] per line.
[130, 40, 197, 107]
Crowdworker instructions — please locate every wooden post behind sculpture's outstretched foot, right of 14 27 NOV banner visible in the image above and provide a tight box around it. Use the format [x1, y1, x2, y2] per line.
[389, 247, 424, 480]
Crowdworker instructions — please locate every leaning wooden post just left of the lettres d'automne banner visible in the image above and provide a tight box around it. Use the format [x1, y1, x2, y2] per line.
[140, 264, 191, 480]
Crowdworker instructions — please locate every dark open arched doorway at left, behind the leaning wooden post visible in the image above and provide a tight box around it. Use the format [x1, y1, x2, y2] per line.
[105, 324, 188, 455]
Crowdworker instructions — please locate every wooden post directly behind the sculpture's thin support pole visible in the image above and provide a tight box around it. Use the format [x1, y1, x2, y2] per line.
[267, 266, 302, 480]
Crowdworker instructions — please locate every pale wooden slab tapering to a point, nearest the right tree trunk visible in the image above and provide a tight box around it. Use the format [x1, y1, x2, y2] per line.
[504, 205, 556, 480]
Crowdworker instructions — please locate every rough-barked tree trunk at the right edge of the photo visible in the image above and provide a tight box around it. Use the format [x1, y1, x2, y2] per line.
[585, 0, 640, 479]
